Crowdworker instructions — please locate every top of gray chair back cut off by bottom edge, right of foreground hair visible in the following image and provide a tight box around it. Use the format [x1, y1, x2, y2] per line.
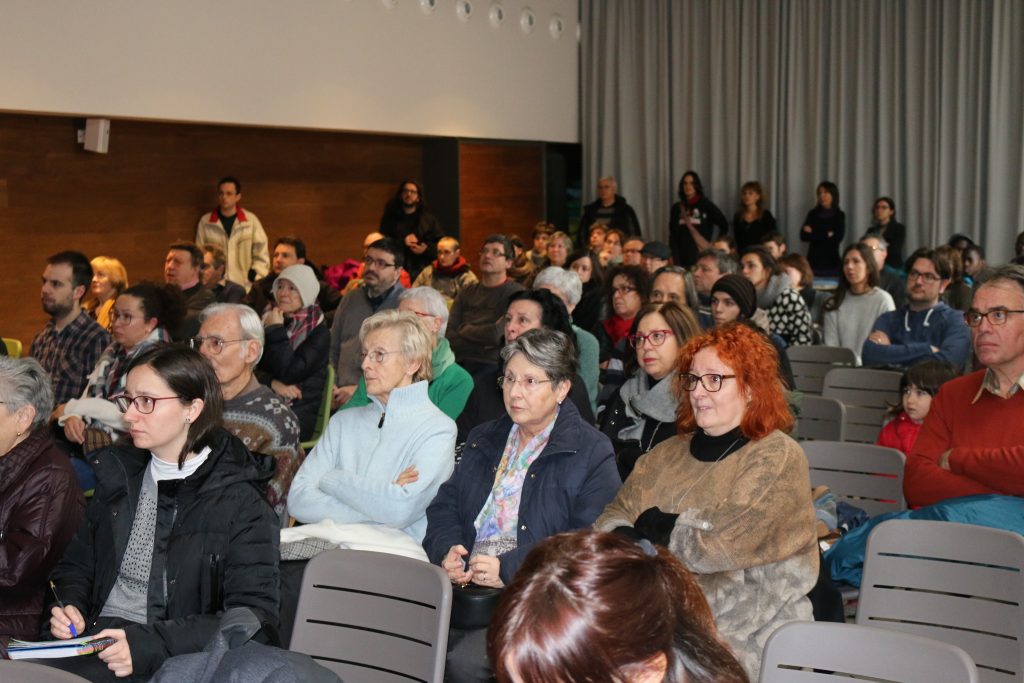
[759, 622, 978, 683]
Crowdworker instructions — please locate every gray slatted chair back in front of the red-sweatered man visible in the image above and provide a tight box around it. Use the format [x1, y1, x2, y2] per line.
[857, 519, 1024, 683]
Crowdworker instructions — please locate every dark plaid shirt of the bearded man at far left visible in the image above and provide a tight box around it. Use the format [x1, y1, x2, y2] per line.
[30, 310, 111, 405]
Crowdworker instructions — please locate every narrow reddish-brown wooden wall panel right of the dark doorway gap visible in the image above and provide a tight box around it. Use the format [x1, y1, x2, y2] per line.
[459, 141, 544, 267]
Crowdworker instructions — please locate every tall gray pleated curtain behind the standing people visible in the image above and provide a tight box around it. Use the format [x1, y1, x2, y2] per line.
[581, 0, 1024, 262]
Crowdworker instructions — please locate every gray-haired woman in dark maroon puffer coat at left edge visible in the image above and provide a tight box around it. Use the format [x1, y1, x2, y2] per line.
[0, 356, 85, 640]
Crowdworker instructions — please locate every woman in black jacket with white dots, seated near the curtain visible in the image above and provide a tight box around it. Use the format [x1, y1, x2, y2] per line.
[740, 247, 814, 346]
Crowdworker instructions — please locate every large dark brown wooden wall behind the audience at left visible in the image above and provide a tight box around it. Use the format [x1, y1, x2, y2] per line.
[0, 115, 423, 343]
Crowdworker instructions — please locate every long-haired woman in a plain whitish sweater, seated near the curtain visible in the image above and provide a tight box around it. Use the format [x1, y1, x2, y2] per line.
[824, 244, 896, 366]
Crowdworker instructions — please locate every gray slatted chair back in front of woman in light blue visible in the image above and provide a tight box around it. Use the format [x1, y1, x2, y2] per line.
[291, 550, 452, 683]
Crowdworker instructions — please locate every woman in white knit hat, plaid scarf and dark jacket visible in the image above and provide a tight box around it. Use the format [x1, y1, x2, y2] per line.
[258, 263, 331, 441]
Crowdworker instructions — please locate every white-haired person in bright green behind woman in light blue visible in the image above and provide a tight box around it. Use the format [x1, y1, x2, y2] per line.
[341, 287, 473, 420]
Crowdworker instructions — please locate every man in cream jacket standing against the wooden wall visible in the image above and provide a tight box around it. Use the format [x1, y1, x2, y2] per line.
[194, 176, 270, 289]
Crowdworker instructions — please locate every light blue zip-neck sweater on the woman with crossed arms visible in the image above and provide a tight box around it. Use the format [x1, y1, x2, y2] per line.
[288, 382, 456, 543]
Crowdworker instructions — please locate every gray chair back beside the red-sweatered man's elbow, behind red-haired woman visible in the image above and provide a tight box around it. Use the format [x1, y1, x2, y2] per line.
[800, 441, 906, 517]
